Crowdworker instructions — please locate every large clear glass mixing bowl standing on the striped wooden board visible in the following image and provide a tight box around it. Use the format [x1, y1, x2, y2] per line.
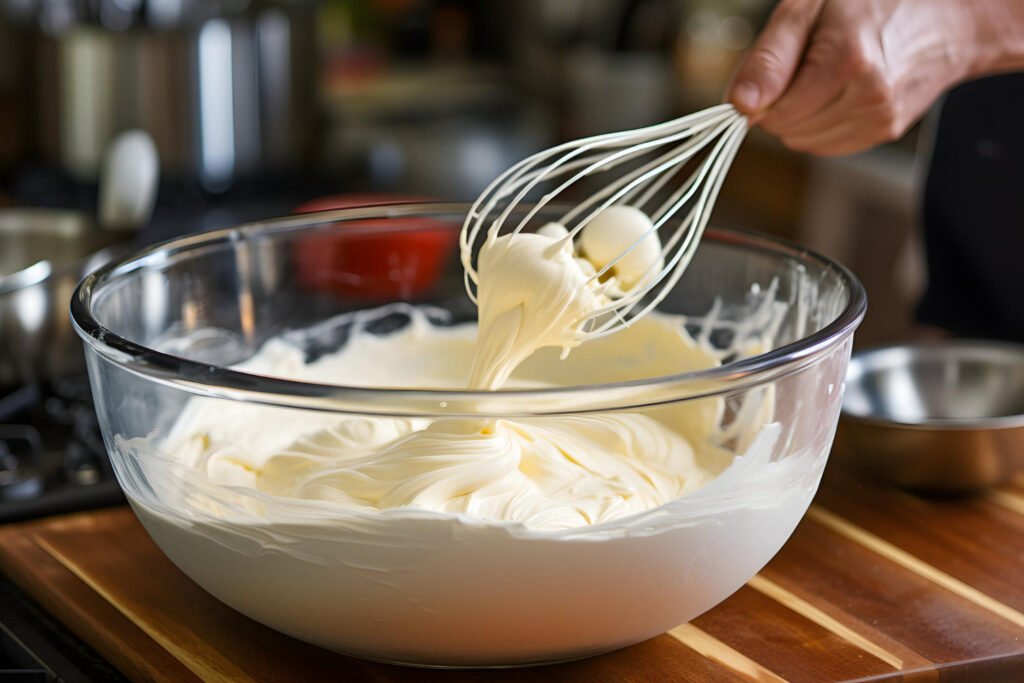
[72, 204, 865, 667]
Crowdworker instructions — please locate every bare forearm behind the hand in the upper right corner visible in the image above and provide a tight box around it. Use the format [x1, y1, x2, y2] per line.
[970, 0, 1024, 77]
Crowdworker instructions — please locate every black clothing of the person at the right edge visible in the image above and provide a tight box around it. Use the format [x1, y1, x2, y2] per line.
[919, 74, 1024, 341]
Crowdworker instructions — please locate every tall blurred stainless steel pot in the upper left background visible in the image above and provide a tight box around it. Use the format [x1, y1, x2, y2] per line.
[27, 0, 315, 191]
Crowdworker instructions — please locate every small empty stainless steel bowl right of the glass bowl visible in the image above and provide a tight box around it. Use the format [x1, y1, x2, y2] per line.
[837, 340, 1024, 492]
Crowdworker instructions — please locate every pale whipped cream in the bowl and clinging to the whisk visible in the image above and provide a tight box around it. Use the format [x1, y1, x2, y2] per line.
[159, 207, 726, 529]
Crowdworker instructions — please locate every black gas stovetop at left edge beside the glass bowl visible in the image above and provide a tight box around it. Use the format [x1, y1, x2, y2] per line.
[0, 378, 124, 523]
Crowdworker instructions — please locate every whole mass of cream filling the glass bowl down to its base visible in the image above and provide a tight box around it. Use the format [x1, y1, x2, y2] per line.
[115, 225, 848, 667]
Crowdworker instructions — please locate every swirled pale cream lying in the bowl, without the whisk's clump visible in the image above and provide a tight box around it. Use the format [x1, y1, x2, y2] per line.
[165, 315, 722, 529]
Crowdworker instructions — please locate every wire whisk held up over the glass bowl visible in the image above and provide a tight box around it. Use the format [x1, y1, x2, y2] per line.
[460, 104, 748, 339]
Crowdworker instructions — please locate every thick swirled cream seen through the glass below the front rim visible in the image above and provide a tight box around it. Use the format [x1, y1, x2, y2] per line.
[186, 415, 707, 529]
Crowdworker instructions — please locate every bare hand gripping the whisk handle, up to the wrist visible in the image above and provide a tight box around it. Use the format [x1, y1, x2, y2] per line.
[727, 0, 987, 156]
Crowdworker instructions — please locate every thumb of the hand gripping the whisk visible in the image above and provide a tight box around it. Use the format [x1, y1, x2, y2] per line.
[725, 0, 825, 117]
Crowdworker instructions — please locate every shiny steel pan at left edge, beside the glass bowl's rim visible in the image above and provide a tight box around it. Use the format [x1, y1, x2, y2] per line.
[0, 209, 127, 387]
